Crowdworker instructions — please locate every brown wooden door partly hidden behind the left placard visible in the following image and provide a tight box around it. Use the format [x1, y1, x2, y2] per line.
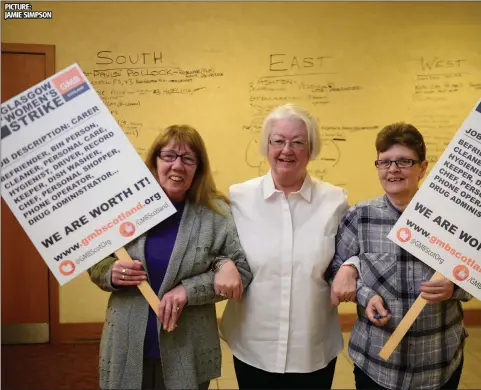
[1, 43, 58, 344]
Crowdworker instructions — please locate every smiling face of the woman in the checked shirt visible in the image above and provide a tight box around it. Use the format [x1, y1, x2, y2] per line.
[377, 144, 427, 199]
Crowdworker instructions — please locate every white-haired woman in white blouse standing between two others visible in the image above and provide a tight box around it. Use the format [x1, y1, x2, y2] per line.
[221, 104, 355, 389]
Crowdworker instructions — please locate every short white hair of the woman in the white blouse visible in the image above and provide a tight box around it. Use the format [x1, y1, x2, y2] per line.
[259, 103, 321, 160]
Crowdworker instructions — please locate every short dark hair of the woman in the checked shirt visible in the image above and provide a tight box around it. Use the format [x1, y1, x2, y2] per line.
[376, 122, 426, 161]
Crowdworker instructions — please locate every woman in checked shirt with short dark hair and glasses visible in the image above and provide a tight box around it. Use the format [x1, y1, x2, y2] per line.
[333, 123, 472, 389]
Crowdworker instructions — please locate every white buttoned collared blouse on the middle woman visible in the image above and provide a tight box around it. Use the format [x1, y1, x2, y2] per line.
[220, 171, 348, 373]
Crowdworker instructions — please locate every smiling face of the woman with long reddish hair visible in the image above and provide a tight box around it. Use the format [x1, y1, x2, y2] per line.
[157, 140, 197, 202]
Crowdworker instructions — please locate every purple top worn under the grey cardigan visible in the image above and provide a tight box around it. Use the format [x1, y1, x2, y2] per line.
[144, 202, 185, 358]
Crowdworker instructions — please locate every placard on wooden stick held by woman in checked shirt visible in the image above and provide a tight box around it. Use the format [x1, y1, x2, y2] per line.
[379, 100, 481, 360]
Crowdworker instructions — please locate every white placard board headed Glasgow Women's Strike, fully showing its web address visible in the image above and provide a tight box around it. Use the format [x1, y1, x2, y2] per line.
[0, 64, 175, 295]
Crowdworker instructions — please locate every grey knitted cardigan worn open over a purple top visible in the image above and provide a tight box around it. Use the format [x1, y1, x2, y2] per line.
[89, 200, 252, 389]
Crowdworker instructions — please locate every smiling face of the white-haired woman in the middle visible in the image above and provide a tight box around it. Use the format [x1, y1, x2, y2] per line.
[267, 119, 309, 184]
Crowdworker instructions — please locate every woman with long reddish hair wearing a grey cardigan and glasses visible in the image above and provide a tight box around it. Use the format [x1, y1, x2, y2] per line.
[89, 126, 252, 389]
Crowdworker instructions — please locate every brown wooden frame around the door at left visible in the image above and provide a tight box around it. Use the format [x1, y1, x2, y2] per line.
[2, 42, 61, 344]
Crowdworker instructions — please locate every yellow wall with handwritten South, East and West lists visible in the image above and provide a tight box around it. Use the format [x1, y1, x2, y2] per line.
[2, 2, 481, 323]
